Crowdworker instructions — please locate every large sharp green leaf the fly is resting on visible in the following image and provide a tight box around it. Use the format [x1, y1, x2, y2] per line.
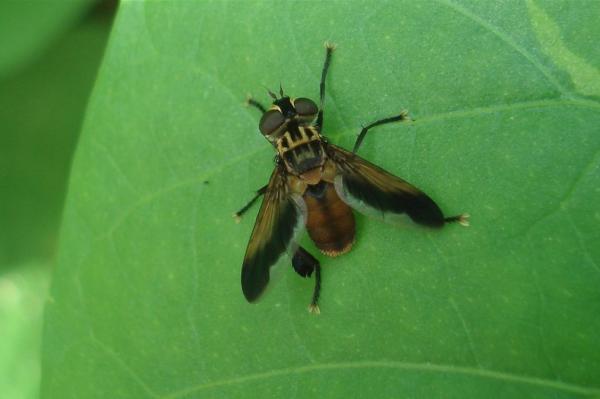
[42, 1, 600, 399]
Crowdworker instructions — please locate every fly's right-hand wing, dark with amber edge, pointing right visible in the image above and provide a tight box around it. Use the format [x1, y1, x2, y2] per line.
[328, 144, 444, 227]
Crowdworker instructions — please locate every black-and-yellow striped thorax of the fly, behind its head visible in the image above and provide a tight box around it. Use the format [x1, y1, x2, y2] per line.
[275, 122, 326, 176]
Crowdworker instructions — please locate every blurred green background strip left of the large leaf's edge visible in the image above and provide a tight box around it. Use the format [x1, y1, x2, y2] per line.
[0, 1, 116, 399]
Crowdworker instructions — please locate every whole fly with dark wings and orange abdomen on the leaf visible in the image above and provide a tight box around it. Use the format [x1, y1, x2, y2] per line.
[235, 45, 468, 313]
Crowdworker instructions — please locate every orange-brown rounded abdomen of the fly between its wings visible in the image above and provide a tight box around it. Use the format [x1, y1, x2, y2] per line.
[303, 181, 354, 256]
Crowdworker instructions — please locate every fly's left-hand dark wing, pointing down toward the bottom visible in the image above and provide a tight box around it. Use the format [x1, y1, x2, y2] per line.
[242, 167, 306, 302]
